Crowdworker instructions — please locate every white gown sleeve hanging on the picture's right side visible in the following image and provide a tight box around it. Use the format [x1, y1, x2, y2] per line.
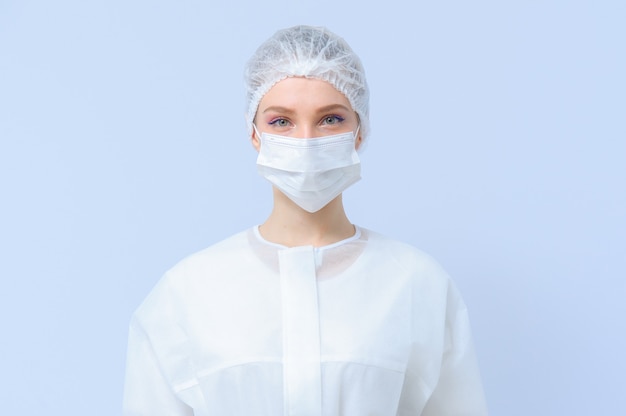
[422, 283, 488, 416]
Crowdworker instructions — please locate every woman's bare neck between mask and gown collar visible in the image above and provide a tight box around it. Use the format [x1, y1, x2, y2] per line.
[259, 189, 355, 247]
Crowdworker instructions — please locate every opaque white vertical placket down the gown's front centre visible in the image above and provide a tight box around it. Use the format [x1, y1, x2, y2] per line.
[278, 246, 322, 416]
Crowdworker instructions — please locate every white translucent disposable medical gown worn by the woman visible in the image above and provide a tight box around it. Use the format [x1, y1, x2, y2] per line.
[124, 227, 487, 416]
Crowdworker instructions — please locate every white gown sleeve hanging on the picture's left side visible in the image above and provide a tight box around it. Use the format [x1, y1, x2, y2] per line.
[123, 318, 194, 416]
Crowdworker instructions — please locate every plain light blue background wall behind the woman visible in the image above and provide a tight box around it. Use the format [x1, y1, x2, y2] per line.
[0, 0, 626, 416]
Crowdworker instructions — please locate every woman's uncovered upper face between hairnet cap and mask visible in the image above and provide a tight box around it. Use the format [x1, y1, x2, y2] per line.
[252, 77, 361, 151]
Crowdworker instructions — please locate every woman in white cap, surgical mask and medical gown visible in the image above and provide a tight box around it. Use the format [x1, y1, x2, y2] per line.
[124, 26, 486, 416]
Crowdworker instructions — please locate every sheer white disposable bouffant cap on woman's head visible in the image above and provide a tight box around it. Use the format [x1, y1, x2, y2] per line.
[244, 26, 369, 138]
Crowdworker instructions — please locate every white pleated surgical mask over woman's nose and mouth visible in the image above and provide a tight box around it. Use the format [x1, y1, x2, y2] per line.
[254, 126, 361, 212]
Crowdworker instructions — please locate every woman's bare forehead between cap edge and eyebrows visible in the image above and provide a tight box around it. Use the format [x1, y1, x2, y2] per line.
[259, 77, 352, 112]
